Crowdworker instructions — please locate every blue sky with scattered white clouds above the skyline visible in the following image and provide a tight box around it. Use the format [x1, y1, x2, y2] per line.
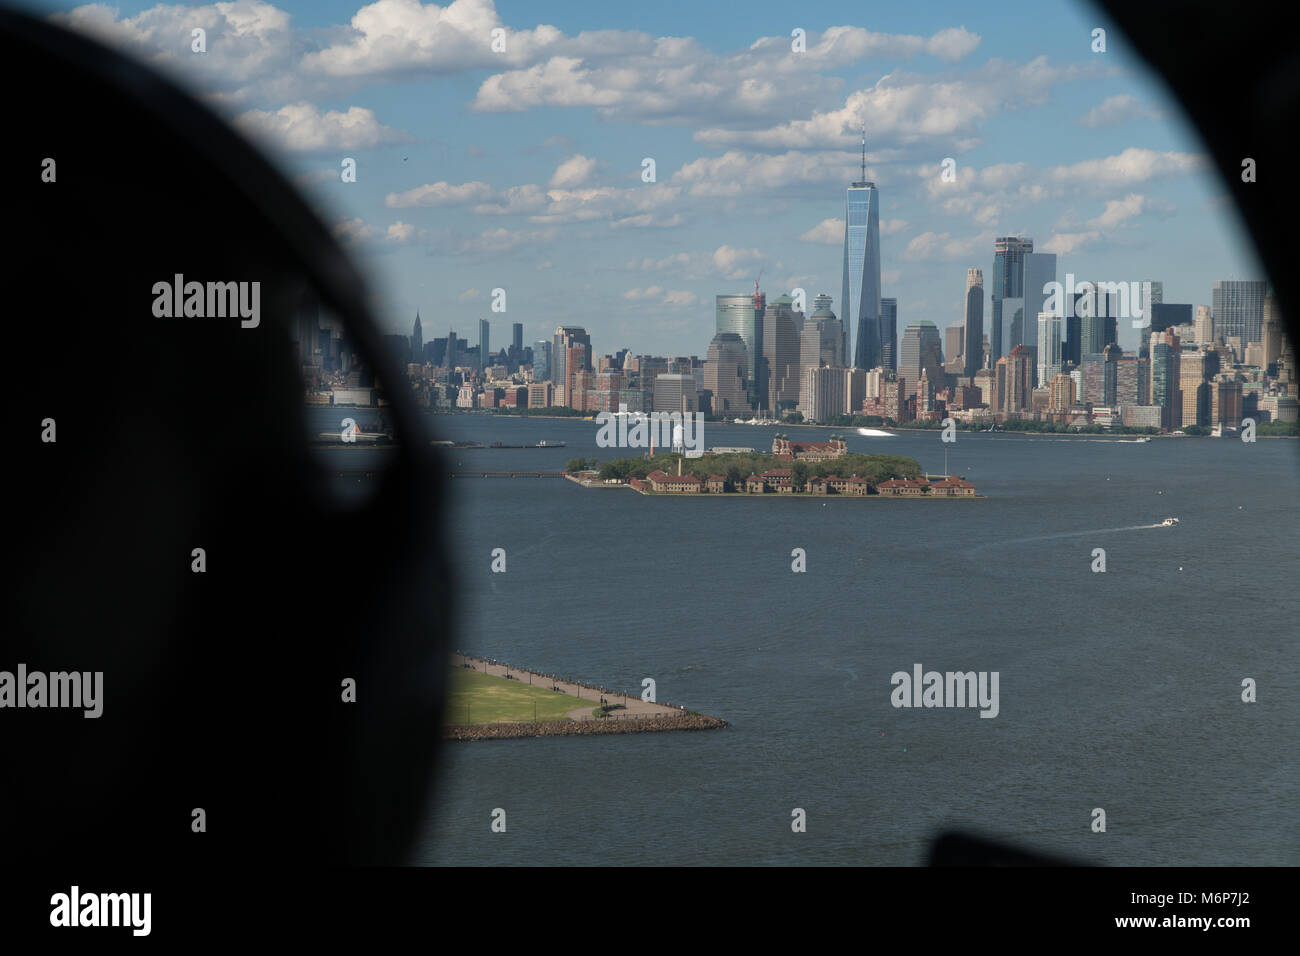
[27, 0, 1265, 356]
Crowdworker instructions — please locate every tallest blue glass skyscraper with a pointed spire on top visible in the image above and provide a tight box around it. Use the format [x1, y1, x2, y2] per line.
[840, 133, 881, 369]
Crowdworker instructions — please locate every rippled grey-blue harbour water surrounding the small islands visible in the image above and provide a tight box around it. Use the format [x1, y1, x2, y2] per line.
[309, 416, 1300, 865]
